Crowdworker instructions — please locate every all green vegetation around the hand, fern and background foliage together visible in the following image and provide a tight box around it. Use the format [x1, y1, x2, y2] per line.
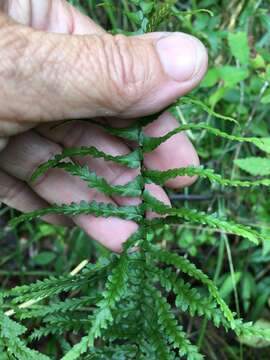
[0, 0, 270, 360]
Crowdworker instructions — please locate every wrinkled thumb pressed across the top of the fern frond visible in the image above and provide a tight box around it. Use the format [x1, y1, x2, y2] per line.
[0, 17, 207, 121]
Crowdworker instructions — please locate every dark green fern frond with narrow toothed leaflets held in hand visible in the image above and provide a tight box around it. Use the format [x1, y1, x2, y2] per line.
[0, 1, 270, 360]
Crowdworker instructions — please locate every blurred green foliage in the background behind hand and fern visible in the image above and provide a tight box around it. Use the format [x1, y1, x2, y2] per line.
[0, 0, 270, 359]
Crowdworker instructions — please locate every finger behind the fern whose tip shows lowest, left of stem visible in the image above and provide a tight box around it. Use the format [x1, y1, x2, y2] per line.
[0, 131, 137, 251]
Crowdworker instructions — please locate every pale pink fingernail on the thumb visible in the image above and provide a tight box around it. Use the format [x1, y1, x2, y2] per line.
[156, 33, 207, 82]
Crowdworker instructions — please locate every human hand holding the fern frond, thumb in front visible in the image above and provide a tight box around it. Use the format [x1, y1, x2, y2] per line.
[0, 0, 207, 251]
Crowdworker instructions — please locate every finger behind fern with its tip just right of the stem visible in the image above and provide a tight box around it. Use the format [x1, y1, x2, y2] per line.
[37, 121, 170, 206]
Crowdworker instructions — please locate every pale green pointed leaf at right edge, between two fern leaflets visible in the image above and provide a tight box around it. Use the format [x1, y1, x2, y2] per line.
[234, 157, 270, 176]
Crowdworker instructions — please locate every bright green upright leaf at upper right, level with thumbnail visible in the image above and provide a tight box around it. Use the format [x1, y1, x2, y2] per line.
[228, 32, 250, 65]
